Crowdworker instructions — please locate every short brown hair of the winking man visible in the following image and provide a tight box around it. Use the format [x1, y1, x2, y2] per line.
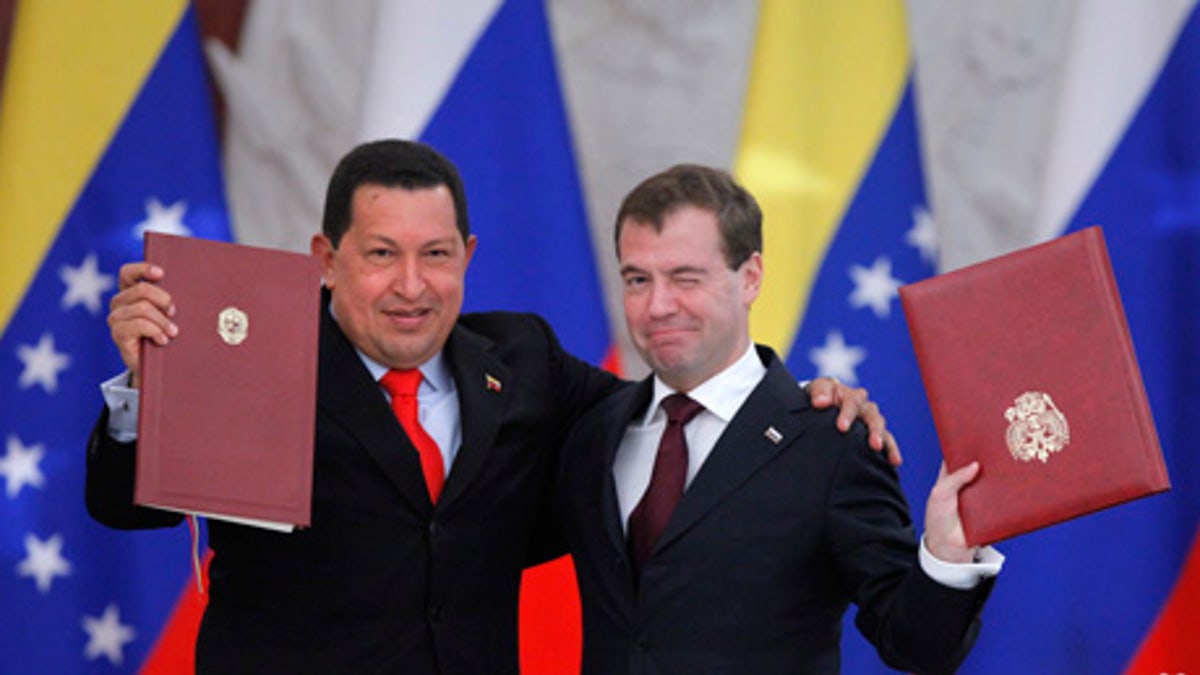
[613, 165, 762, 269]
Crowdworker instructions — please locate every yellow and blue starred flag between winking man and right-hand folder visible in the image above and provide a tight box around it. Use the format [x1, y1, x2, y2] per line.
[736, 0, 941, 674]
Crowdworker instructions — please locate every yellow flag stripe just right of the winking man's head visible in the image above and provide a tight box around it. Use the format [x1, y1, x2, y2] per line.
[734, 0, 910, 354]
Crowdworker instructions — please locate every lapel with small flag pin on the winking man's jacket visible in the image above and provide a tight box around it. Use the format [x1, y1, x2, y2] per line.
[655, 347, 809, 549]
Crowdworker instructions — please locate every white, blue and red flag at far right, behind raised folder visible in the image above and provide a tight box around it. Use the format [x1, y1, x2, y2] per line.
[970, 0, 1200, 675]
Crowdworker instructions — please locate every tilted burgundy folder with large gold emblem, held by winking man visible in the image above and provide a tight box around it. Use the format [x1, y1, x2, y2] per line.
[900, 227, 1170, 545]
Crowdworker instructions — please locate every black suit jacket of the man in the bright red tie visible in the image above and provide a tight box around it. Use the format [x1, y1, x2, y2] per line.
[86, 306, 617, 674]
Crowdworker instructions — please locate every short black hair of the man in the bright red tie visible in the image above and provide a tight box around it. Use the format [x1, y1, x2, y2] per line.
[320, 139, 470, 249]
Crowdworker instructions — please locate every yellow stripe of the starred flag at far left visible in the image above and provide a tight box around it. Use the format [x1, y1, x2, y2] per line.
[0, 0, 186, 327]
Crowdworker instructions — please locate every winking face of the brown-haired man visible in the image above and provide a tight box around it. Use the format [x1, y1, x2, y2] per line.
[617, 205, 762, 392]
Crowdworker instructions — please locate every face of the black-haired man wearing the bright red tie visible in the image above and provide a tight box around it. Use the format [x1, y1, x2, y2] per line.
[312, 184, 475, 369]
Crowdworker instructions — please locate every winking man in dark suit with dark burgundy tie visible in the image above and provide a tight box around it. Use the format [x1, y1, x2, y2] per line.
[557, 166, 1002, 675]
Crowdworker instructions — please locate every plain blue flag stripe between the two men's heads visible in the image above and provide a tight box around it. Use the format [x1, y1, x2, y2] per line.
[421, 0, 610, 363]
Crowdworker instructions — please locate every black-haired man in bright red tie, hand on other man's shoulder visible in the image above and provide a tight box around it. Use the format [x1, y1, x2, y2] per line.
[86, 141, 890, 674]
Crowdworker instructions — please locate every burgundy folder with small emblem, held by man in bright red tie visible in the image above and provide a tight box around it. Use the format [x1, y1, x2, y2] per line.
[134, 233, 320, 530]
